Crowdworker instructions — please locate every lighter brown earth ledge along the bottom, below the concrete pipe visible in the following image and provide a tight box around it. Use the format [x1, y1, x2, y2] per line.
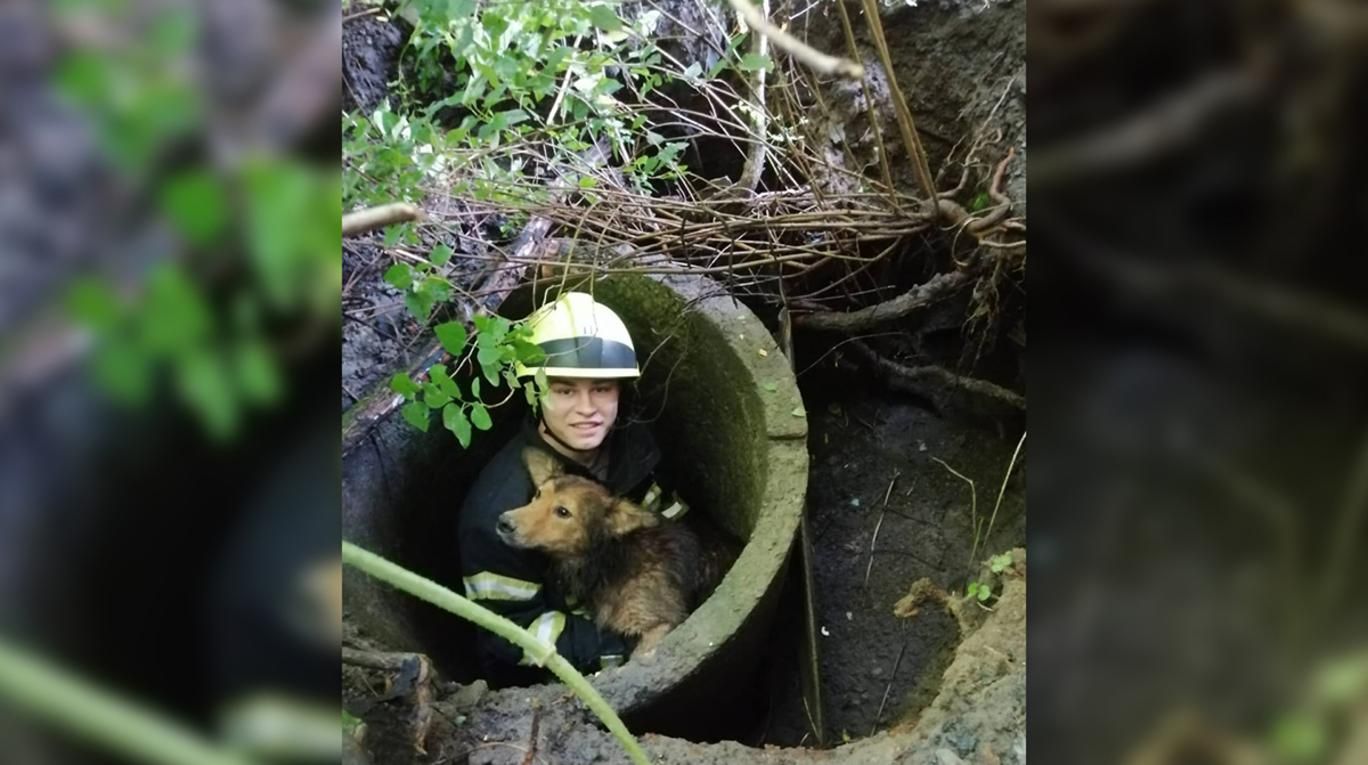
[343, 563, 1026, 765]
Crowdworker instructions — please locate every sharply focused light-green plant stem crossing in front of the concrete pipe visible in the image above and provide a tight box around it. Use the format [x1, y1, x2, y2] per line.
[342, 541, 650, 765]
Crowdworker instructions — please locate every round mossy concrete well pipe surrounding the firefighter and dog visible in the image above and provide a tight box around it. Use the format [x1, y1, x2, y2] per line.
[342, 275, 807, 739]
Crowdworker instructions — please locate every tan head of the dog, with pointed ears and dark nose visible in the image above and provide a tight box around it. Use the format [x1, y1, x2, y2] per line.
[498, 449, 659, 558]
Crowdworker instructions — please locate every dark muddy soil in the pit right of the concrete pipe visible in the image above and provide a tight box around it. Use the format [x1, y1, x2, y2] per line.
[755, 349, 1026, 746]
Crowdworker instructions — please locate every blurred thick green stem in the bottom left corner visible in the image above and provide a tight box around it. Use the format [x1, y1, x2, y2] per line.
[0, 639, 250, 765]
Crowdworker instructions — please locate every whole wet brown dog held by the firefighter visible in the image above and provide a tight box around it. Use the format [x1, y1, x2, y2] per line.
[498, 449, 702, 658]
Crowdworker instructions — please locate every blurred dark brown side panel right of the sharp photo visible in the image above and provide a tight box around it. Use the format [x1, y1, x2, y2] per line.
[1027, 0, 1368, 764]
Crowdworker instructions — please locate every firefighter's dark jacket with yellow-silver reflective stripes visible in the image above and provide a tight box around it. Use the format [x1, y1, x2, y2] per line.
[460, 420, 668, 687]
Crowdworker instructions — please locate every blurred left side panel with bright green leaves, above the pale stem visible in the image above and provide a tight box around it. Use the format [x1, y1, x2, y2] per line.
[0, 0, 341, 762]
